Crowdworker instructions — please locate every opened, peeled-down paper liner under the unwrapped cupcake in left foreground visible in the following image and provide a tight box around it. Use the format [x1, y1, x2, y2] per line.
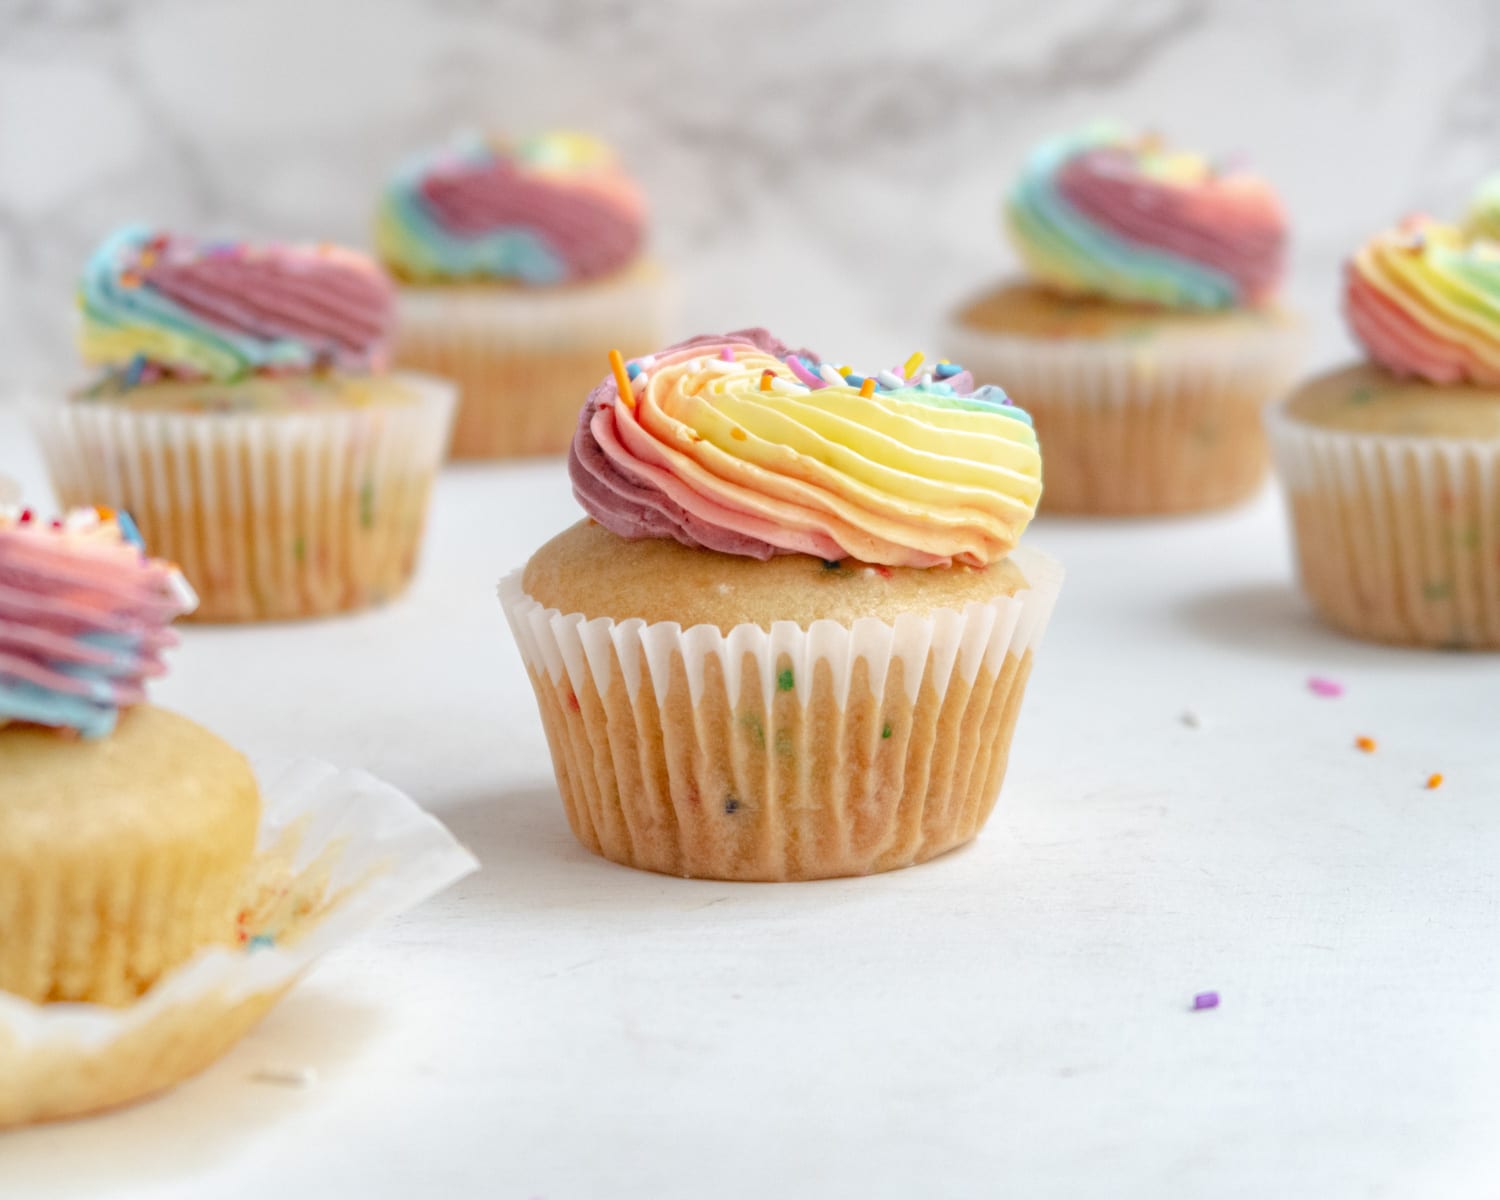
[0, 762, 479, 1128]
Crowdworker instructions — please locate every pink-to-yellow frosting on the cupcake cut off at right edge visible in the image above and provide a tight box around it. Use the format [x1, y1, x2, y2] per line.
[1344, 216, 1500, 384]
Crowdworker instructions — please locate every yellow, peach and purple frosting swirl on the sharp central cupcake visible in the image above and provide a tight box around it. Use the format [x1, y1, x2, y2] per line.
[569, 330, 1041, 567]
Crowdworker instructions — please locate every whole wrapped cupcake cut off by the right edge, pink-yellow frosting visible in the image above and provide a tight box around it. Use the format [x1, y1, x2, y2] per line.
[1269, 218, 1500, 648]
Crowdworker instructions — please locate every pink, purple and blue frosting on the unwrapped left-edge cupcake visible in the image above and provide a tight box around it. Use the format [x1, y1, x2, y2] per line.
[0, 509, 198, 738]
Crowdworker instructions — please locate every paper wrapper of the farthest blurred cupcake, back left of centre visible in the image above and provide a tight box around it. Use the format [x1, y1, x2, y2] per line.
[395, 264, 677, 459]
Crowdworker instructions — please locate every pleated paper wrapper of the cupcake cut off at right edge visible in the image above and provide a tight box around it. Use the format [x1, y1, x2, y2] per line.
[1268, 410, 1500, 648]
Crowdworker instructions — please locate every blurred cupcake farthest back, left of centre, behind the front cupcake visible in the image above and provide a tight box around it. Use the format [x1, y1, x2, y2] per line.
[375, 134, 671, 458]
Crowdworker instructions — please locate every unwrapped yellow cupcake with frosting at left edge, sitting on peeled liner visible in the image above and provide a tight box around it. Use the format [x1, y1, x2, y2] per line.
[0, 510, 260, 1005]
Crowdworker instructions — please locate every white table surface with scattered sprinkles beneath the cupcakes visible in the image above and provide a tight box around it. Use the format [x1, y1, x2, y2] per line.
[0, 410, 1500, 1200]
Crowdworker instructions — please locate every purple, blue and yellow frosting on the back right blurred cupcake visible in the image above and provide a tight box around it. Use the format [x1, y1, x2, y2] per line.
[1005, 125, 1287, 309]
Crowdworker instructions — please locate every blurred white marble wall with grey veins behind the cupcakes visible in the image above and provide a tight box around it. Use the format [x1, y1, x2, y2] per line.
[0, 0, 1500, 395]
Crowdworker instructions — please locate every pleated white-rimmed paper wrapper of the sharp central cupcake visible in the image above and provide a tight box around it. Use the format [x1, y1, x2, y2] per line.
[500, 549, 1062, 881]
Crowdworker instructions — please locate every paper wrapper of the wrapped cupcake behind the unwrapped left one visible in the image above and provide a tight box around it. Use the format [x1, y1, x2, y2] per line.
[33, 372, 455, 621]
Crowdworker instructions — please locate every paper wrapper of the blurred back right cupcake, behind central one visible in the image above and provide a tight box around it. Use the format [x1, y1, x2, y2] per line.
[945, 318, 1305, 515]
